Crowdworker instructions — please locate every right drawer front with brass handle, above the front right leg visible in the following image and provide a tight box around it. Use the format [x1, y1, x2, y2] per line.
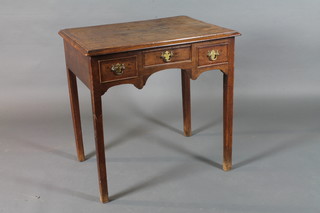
[197, 43, 228, 67]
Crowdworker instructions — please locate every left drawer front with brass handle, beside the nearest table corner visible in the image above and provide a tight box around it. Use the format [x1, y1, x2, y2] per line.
[98, 56, 138, 83]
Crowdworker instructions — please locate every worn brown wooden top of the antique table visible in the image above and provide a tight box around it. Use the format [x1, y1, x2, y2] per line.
[59, 16, 240, 56]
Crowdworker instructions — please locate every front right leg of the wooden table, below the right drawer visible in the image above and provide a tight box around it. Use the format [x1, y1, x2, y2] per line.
[223, 66, 233, 171]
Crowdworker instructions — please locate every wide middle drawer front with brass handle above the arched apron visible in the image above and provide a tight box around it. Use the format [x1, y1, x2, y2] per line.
[143, 46, 191, 66]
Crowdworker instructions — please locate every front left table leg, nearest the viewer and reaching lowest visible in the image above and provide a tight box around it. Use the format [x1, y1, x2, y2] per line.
[91, 92, 109, 203]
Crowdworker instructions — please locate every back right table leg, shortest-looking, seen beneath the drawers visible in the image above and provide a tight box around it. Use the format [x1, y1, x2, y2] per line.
[181, 70, 192, 136]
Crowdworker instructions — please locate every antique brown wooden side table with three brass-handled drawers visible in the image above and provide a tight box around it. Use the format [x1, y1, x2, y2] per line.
[59, 16, 240, 202]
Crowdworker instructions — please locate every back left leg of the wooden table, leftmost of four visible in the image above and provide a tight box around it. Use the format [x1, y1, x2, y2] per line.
[67, 69, 85, 161]
